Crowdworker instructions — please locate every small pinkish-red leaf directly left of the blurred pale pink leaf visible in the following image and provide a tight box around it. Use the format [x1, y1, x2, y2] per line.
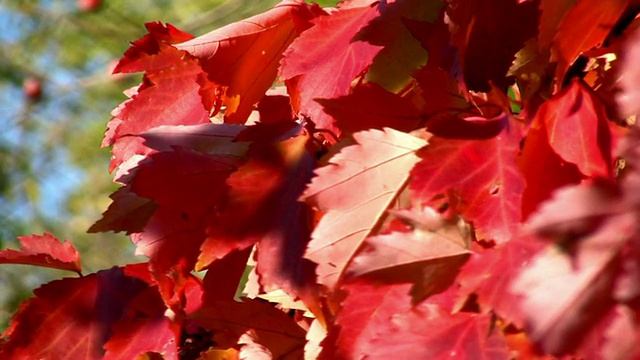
[457, 233, 544, 327]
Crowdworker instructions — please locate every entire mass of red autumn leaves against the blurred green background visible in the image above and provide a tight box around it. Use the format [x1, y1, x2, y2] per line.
[0, 0, 640, 359]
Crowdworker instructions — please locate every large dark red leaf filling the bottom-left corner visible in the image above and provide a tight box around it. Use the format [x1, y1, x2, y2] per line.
[0, 267, 169, 359]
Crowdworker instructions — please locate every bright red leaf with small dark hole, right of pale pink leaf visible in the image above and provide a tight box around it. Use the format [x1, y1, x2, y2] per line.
[411, 114, 524, 243]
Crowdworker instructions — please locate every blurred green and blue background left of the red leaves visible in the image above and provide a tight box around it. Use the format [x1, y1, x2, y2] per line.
[0, 0, 335, 331]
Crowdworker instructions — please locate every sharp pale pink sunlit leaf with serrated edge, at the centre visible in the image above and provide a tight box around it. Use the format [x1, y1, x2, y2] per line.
[301, 129, 425, 289]
